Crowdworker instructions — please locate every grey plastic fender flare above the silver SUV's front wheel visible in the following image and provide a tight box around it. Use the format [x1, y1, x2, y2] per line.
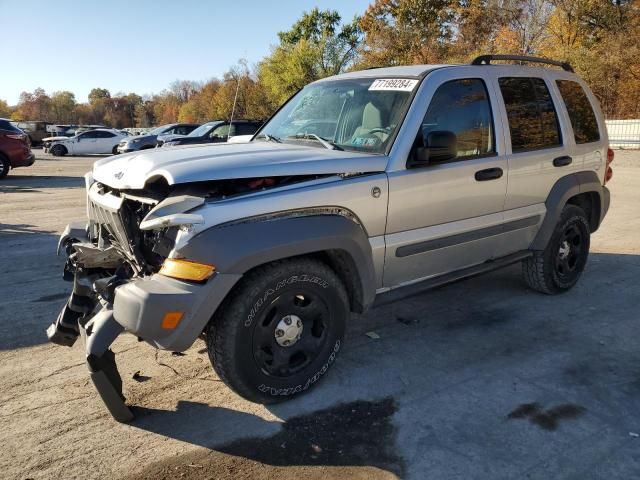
[178, 213, 376, 312]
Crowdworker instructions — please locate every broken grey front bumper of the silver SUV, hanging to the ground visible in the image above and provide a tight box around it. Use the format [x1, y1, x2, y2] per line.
[47, 224, 241, 422]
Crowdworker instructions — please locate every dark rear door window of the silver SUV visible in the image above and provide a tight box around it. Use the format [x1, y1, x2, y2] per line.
[498, 77, 562, 153]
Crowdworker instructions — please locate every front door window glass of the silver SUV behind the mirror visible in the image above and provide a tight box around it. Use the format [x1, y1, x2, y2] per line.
[421, 78, 495, 159]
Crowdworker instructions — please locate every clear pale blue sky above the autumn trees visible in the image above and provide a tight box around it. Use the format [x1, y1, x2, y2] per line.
[0, 0, 370, 105]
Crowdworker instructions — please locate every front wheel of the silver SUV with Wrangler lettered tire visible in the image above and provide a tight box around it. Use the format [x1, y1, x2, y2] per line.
[206, 258, 349, 404]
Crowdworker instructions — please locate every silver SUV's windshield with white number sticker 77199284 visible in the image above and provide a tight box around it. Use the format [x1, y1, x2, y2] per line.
[255, 78, 418, 154]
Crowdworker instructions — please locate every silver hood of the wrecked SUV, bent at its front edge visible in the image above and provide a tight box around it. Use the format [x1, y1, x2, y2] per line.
[93, 142, 388, 189]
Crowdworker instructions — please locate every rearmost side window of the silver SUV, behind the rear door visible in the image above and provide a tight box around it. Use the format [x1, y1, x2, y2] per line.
[556, 80, 600, 144]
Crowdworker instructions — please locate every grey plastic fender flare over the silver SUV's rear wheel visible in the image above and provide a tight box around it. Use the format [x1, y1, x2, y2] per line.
[530, 171, 609, 250]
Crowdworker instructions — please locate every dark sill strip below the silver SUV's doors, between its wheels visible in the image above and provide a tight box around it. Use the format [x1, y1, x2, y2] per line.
[373, 250, 533, 308]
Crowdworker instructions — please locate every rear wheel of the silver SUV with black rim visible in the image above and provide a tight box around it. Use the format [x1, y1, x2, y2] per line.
[522, 205, 590, 295]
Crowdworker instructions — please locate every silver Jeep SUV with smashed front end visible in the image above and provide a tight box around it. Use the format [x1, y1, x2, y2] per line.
[48, 55, 613, 421]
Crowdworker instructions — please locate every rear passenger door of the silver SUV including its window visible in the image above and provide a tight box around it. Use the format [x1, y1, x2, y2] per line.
[496, 74, 577, 255]
